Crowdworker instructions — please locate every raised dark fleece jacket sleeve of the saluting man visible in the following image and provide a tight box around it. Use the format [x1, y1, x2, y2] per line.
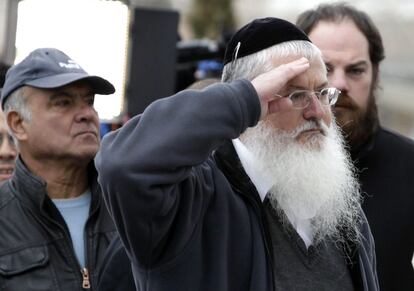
[95, 80, 260, 269]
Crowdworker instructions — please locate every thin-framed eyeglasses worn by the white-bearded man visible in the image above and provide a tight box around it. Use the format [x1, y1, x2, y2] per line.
[277, 87, 341, 109]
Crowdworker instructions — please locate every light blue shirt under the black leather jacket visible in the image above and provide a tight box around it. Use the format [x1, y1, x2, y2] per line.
[52, 190, 91, 267]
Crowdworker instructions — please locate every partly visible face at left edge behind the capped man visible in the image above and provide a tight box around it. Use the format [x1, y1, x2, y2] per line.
[0, 110, 17, 183]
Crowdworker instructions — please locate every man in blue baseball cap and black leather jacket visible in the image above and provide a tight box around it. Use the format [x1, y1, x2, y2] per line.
[0, 48, 115, 291]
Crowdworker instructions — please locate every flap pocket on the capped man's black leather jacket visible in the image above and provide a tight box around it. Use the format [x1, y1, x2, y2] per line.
[0, 246, 59, 291]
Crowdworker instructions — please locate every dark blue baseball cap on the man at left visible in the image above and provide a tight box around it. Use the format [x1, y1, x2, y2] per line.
[1, 48, 115, 109]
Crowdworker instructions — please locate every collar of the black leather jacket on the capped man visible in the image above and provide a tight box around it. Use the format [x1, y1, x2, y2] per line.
[8, 156, 101, 214]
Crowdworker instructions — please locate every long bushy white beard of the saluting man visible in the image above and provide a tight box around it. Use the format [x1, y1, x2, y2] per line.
[240, 121, 360, 243]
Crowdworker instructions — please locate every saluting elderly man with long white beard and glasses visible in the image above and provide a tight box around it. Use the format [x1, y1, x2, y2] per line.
[96, 18, 378, 291]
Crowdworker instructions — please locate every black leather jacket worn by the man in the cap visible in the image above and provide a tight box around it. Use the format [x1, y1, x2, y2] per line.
[0, 158, 116, 291]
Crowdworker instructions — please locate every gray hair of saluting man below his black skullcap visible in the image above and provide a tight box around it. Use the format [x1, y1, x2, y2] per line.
[221, 40, 324, 82]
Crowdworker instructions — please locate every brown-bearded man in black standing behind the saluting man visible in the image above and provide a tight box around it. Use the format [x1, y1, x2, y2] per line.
[297, 3, 414, 291]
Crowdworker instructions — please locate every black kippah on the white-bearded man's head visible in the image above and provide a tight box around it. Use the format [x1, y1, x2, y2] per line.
[223, 17, 310, 65]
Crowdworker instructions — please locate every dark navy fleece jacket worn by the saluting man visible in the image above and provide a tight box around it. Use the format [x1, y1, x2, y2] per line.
[96, 80, 377, 291]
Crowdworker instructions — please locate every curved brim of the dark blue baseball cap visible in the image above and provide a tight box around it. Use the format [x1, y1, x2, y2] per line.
[25, 73, 115, 95]
